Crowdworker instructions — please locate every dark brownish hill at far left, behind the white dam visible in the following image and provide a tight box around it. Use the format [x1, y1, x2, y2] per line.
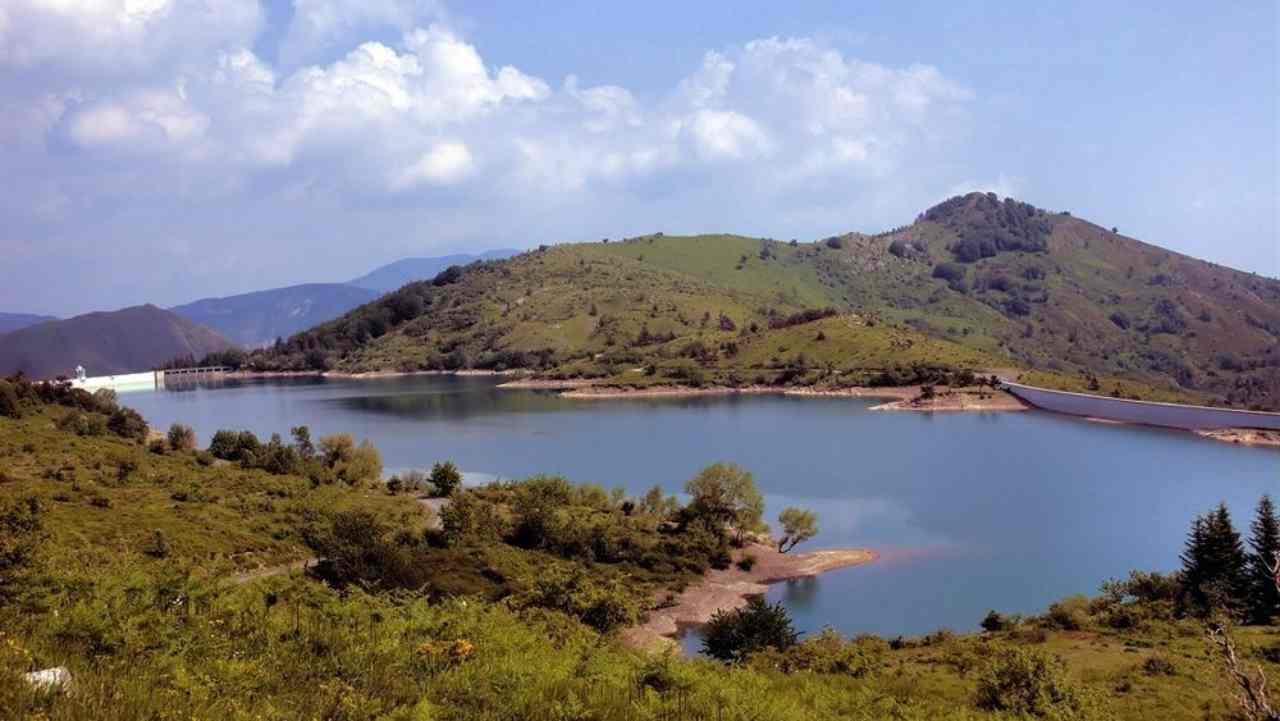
[0, 305, 234, 378]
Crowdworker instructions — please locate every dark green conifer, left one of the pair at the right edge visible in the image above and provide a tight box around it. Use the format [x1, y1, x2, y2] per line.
[1181, 503, 1249, 613]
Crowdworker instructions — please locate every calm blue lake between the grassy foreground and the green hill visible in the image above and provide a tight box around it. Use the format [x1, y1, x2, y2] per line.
[122, 375, 1280, 643]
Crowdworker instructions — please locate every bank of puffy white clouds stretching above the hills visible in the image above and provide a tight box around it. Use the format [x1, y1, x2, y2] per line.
[0, 7, 972, 315]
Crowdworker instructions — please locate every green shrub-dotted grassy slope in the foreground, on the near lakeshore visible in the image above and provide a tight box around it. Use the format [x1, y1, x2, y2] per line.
[0, 389, 1280, 721]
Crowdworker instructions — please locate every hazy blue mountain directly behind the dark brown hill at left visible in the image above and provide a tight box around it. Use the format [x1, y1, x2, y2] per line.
[170, 283, 379, 347]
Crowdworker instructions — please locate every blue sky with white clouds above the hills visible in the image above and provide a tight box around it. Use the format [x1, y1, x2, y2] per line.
[0, 0, 1280, 316]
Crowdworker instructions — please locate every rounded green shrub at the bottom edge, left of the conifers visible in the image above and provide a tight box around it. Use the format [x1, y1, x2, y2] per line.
[977, 647, 1094, 718]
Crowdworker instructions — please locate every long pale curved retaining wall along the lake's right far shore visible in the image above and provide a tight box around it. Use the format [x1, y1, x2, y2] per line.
[1005, 382, 1280, 430]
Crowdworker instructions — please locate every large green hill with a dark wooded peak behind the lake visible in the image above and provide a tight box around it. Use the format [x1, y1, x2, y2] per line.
[253, 193, 1280, 409]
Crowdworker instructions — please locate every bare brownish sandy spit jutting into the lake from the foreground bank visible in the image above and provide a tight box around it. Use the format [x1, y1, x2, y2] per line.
[622, 544, 877, 649]
